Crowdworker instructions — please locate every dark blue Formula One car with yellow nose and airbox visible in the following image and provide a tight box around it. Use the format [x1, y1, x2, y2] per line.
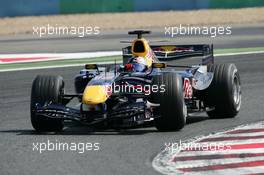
[31, 30, 241, 131]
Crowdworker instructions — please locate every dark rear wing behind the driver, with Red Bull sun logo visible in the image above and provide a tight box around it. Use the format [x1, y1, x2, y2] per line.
[122, 44, 214, 65]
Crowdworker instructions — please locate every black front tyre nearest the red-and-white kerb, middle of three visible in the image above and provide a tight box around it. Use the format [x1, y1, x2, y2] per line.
[151, 73, 187, 131]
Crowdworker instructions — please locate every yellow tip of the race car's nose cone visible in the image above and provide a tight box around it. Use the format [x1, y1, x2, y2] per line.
[82, 85, 108, 105]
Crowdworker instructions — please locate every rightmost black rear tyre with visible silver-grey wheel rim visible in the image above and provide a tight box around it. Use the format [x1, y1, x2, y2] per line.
[204, 64, 241, 118]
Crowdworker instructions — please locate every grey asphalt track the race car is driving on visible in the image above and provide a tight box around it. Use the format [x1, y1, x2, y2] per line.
[0, 25, 264, 175]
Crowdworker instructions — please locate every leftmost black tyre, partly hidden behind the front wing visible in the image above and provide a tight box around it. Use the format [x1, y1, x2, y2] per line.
[30, 75, 64, 132]
